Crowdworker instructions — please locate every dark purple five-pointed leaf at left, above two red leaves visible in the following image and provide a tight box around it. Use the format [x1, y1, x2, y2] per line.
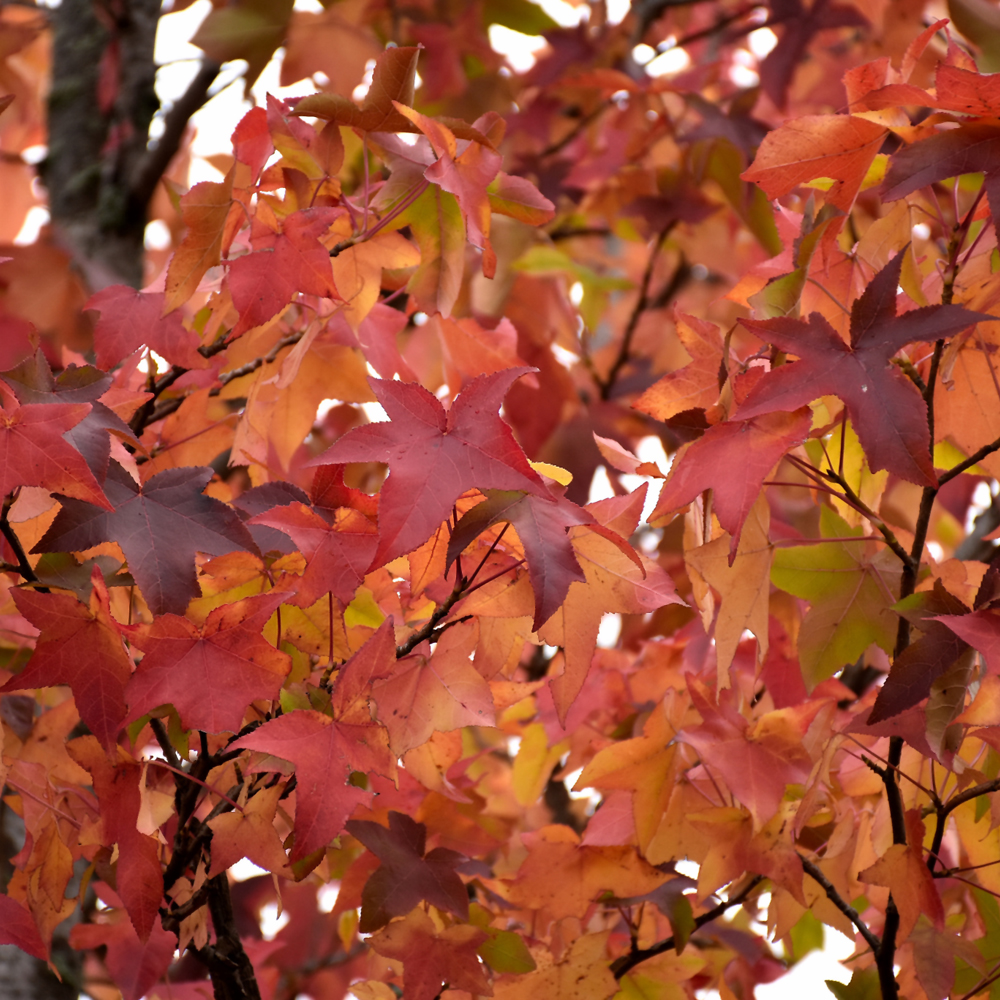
[35, 462, 256, 614]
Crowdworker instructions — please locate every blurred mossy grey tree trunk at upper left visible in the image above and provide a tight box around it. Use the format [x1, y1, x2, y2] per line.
[43, 0, 160, 289]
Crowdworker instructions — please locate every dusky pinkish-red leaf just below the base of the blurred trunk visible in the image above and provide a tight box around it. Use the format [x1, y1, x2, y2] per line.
[86, 285, 209, 369]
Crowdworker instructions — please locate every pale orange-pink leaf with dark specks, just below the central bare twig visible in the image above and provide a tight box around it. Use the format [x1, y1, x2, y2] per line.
[372, 626, 496, 755]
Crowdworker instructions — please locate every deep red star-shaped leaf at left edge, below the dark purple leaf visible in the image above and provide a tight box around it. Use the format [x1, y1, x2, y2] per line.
[0, 566, 132, 750]
